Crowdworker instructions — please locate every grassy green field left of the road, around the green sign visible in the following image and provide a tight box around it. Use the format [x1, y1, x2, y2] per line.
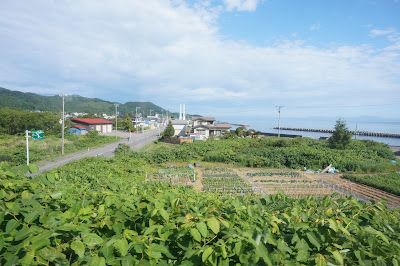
[0, 134, 121, 165]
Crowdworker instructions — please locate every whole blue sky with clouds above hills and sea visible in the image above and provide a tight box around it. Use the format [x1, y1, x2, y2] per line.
[0, 0, 400, 127]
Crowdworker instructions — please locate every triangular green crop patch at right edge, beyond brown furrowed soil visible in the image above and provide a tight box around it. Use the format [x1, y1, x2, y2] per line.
[343, 173, 400, 196]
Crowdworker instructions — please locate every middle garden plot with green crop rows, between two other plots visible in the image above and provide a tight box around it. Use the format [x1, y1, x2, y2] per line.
[201, 167, 255, 196]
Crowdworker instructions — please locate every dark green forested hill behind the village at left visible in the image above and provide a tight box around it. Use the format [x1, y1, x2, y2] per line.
[0, 87, 165, 115]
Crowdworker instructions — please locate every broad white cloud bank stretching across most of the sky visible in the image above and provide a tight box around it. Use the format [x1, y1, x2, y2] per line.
[0, 0, 400, 116]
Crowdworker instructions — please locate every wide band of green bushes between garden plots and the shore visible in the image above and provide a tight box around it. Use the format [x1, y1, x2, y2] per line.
[132, 138, 394, 173]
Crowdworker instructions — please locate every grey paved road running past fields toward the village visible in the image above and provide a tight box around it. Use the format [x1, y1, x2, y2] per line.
[28, 128, 164, 176]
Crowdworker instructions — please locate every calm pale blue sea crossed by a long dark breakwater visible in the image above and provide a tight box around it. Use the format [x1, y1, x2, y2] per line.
[222, 117, 400, 146]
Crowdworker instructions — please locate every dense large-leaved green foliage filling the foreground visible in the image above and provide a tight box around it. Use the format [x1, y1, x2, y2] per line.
[0, 161, 400, 265]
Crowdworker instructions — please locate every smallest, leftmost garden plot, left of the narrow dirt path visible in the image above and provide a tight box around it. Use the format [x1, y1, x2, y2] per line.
[146, 166, 195, 186]
